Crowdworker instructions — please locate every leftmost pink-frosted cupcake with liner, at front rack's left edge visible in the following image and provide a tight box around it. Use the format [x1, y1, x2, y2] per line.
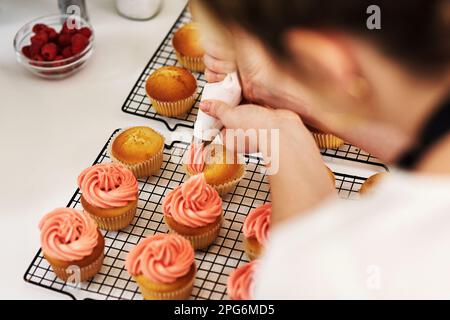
[39, 208, 105, 282]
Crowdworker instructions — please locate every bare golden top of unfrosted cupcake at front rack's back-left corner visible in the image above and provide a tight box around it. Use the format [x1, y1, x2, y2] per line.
[111, 126, 164, 164]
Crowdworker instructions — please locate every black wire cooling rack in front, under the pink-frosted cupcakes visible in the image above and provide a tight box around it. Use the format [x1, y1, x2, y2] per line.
[24, 129, 383, 300]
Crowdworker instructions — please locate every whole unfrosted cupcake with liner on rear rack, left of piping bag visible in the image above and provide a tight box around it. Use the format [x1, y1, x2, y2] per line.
[145, 66, 197, 117]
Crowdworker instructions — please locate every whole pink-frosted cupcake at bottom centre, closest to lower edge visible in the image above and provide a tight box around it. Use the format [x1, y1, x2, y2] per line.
[125, 234, 197, 300]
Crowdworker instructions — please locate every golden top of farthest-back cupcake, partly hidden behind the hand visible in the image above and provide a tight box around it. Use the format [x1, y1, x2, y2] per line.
[172, 22, 205, 57]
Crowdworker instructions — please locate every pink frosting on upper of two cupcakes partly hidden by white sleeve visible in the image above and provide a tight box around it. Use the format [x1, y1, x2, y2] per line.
[242, 203, 272, 245]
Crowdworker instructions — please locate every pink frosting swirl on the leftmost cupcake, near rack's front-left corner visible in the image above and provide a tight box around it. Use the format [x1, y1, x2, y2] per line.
[39, 208, 99, 261]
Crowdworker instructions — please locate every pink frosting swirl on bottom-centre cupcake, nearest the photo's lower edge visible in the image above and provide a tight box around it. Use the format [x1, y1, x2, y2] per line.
[125, 234, 194, 284]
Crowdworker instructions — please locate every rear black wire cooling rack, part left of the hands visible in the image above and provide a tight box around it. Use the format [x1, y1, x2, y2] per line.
[122, 8, 206, 131]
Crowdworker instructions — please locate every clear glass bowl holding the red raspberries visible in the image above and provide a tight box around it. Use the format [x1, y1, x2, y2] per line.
[14, 14, 94, 79]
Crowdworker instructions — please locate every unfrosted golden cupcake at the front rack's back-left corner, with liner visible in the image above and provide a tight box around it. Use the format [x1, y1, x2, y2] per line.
[108, 127, 164, 178]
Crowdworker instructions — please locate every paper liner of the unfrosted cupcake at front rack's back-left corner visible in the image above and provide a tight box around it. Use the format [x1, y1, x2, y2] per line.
[108, 129, 164, 178]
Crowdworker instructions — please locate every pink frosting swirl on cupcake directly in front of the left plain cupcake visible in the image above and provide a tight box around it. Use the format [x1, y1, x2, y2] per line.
[78, 163, 138, 209]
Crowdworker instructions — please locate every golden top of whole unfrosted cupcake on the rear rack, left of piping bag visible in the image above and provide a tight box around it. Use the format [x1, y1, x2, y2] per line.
[145, 66, 197, 102]
